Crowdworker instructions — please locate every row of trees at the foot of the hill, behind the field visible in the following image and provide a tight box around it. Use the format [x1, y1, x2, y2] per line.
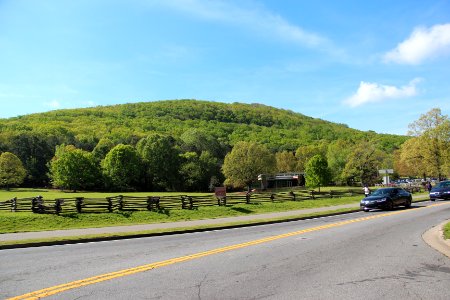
[0, 102, 450, 191]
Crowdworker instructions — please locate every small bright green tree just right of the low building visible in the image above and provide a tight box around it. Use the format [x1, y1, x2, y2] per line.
[305, 154, 331, 192]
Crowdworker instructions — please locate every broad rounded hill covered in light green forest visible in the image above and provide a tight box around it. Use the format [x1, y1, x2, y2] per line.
[0, 100, 406, 152]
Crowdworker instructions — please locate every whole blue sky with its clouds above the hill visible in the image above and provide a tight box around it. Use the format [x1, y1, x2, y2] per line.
[0, 0, 450, 134]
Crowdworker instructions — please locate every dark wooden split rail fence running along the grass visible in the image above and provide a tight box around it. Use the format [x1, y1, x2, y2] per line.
[0, 189, 368, 214]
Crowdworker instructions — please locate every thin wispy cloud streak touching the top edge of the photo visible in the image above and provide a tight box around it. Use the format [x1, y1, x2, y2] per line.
[158, 0, 335, 50]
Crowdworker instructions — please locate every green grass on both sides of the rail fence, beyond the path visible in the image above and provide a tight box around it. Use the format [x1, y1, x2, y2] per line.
[0, 187, 428, 233]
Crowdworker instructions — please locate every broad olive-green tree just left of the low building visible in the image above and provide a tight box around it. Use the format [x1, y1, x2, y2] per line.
[222, 142, 276, 190]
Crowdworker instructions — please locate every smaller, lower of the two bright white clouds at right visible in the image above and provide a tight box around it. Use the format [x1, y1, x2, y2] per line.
[344, 78, 421, 107]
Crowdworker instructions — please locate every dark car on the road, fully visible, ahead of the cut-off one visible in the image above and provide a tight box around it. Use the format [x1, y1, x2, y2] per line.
[360, 187, 412, 211]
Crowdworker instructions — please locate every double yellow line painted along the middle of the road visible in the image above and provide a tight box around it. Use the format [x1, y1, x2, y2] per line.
[8, 202, 449, 300]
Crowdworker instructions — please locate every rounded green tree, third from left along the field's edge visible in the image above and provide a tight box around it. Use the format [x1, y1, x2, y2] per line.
[101, 144, 142, 191]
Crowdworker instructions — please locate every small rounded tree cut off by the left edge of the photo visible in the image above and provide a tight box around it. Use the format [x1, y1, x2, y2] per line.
[0, 152, 27, 190]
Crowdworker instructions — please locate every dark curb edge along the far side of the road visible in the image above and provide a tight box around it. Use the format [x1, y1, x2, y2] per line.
[0, 209, 360, 251]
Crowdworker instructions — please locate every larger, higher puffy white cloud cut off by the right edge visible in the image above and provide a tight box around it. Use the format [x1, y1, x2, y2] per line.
[384, 23, 450, 65]
